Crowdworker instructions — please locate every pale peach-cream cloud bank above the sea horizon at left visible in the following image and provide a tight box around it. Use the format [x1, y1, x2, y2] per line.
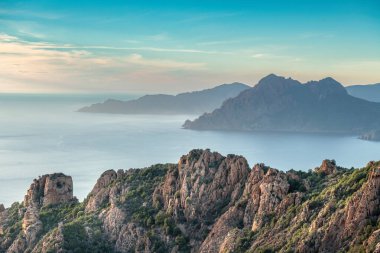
[0, 34, 206, 91]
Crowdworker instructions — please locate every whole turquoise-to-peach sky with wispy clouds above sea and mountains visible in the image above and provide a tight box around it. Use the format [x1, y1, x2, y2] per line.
[0, 0, 380, 93]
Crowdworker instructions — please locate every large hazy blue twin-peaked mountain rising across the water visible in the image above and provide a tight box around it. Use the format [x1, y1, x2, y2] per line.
[184, 74, 380, 134]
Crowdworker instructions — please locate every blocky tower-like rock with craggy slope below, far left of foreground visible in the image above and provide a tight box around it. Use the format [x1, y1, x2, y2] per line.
[0, 173, 77, 252]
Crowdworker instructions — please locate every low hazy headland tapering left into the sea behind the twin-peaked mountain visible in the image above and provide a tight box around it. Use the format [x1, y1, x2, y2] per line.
[78, 82, 250, 114]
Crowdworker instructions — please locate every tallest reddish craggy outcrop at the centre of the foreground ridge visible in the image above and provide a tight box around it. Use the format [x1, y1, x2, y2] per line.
[154, 150, 250, 247]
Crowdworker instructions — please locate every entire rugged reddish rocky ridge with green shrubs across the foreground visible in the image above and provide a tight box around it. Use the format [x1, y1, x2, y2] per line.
[0, 150, 380, 253]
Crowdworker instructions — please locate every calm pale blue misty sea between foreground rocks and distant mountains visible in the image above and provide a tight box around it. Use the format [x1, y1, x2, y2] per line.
[0, 94, 380, 206]
